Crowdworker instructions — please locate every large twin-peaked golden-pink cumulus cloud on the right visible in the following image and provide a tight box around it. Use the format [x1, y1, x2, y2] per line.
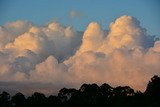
[65, 16, 156, 90]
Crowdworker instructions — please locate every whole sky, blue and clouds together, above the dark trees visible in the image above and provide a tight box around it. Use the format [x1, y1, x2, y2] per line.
[0, 0, 160, 94]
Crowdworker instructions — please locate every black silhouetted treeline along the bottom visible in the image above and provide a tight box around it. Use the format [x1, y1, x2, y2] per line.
[0, 76, 160, 107]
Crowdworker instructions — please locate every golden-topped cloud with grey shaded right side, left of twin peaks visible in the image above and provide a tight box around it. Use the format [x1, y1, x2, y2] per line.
[5, 22, 81, 61]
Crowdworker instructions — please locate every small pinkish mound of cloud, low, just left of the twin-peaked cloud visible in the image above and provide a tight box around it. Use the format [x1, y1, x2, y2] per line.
[30, 56, 67, 83]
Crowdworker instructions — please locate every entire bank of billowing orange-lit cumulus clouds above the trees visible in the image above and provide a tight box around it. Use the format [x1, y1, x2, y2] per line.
[0, 16, 160, 93]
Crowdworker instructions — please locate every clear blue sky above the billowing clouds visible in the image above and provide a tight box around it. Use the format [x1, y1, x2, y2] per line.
[0, 0, 160, 35]
